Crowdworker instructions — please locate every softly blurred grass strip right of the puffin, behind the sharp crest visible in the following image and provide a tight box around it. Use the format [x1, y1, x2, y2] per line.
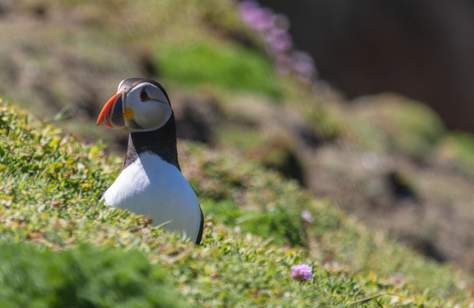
[184, 149, 474, 302]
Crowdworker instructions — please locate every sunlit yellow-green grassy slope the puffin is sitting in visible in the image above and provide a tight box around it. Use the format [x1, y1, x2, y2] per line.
[0, 102, 472, 306]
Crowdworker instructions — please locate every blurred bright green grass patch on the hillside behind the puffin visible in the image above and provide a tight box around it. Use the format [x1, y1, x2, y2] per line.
[155, 40, 282, 98]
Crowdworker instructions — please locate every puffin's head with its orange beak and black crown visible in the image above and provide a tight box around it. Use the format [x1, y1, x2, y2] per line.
[97, 78, 173, 132]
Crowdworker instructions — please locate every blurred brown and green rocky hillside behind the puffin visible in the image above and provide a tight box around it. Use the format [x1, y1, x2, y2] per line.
[0, 0, 474, 271]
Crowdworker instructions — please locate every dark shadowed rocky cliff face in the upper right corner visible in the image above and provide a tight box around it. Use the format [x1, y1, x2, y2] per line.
[262, 0, 474, 131]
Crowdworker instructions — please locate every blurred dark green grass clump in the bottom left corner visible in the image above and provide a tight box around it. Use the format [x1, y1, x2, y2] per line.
[0, 243, 184, 308]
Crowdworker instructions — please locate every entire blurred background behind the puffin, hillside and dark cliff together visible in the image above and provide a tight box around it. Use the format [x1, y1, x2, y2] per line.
[0, 0, 474, 271]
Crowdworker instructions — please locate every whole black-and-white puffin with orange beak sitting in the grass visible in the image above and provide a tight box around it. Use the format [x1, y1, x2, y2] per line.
[97, 78, 204, 244]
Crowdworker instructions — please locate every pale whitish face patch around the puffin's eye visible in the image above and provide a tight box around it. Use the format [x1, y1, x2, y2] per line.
[124, 82, 172, 131]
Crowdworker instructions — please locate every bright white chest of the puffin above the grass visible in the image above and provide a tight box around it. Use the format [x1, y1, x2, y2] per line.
[103, 152, 201, 240]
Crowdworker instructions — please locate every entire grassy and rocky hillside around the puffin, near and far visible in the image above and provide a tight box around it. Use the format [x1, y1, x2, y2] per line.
[0, 0, 474, 307]
